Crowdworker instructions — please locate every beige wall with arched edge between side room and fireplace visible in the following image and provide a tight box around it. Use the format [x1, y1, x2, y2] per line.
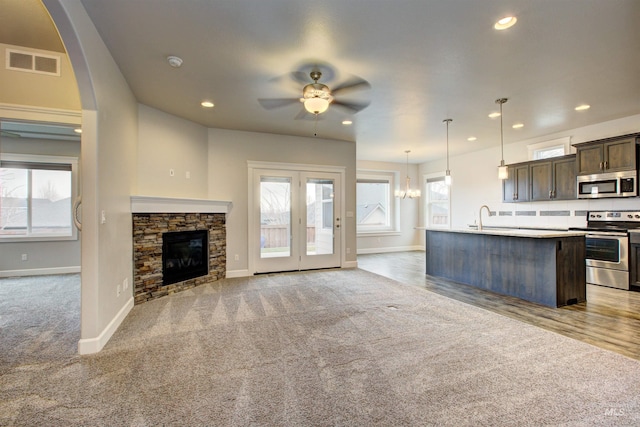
[43, 0, 138, 353]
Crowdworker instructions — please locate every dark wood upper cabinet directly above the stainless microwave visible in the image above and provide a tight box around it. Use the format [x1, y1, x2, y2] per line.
[574, 134, 638, 175]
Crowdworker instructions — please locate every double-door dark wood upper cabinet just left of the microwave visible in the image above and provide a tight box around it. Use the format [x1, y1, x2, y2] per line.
[529, 154, 576, 201]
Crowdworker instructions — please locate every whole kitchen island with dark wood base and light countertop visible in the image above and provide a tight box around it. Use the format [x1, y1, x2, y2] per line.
[425, 229, 587, 307]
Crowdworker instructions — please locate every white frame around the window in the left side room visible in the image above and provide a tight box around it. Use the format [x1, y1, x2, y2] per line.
[0, 153, 78, 243]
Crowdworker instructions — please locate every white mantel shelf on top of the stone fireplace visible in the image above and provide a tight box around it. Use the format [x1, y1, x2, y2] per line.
[131, 196, 231, 214]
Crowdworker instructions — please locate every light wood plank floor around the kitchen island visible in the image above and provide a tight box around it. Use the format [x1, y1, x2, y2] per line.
[358, 251, 640, 360]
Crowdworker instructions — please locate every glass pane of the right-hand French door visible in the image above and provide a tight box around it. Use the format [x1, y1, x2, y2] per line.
[306, 178, 334, 255]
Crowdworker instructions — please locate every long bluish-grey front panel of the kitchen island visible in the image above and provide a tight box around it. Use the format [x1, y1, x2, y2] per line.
[426, 230, 584, 307]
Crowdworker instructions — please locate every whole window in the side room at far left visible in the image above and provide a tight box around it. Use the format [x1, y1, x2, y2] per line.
[0, 154, 77, 241]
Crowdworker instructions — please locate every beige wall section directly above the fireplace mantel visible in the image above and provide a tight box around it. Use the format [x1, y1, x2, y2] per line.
[135, 104, 208, 199]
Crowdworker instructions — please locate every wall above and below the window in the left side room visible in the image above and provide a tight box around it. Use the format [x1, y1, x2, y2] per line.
[0, 138, 80, 276]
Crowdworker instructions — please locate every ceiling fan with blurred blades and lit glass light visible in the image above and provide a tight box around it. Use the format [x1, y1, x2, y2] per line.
[258, 69, 371, 119]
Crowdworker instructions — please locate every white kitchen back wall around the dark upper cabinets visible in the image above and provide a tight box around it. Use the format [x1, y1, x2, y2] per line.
[420, 115, 640, 234]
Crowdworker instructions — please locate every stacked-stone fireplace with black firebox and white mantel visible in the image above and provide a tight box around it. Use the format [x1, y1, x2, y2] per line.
[131, 196, 231, 304]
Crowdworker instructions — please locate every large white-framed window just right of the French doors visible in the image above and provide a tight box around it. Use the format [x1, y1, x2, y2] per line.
[356, 172, 396, 233]
